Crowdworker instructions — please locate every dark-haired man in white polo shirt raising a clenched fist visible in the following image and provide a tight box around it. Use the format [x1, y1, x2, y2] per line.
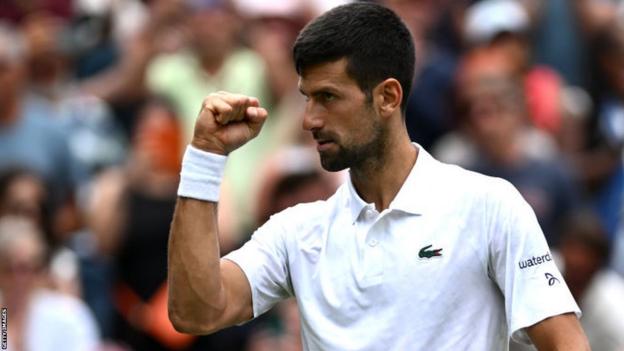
[169, 3, 588, 350]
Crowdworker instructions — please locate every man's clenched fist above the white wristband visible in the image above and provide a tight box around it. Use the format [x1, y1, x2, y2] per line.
[191, 91, 267, 155]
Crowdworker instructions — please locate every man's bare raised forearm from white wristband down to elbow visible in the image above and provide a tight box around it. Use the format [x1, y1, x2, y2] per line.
[168, 197, 225, 332]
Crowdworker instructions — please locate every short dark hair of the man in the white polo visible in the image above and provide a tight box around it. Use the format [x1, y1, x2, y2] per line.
[293, 2, 415, 111]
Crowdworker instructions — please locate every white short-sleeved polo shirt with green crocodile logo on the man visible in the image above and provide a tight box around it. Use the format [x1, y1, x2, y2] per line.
[225, 146, 580, 351]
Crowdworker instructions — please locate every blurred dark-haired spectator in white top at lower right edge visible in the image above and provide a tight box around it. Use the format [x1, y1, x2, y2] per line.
[560, 211, 624, 351]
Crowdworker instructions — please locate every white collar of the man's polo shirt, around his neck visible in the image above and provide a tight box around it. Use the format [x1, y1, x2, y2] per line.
[347, 143, 436, 223]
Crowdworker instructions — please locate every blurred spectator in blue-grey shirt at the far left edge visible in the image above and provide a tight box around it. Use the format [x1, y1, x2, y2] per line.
[0, 24, 84, 242]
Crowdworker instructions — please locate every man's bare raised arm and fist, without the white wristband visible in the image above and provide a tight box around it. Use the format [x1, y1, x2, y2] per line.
[168, 92, 267, 334]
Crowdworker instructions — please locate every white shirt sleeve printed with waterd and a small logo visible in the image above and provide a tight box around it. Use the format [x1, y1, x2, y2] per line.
[488, 180, 580, 343]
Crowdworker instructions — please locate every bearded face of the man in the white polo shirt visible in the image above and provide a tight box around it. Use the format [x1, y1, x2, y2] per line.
[299, 59, 387, 172]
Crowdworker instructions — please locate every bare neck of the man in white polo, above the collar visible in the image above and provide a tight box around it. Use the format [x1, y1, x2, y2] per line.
[350, 128, 418, 212]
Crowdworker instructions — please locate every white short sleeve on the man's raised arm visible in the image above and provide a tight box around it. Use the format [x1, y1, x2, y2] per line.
[223, 214, 292, 318]
